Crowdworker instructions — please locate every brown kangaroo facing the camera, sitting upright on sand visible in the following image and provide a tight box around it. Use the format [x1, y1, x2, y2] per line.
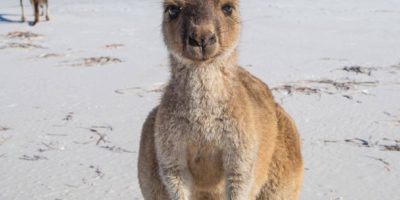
[138, 0, 303, 200]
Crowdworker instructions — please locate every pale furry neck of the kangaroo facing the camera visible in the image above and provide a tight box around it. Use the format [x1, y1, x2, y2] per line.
[170, 52, 237, 104]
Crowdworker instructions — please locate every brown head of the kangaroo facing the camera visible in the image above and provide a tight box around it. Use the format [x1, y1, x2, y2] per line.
[163, 0, 240, 63]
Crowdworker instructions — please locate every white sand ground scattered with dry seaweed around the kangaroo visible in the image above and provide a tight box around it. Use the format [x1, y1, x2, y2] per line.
[0, 0, 400, 200]
